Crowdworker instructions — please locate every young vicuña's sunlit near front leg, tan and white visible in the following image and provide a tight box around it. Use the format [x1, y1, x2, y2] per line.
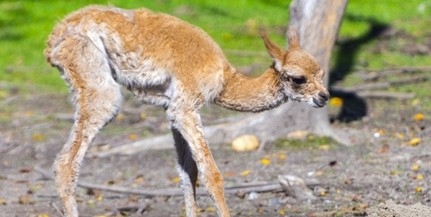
[167, 107, 230, 217]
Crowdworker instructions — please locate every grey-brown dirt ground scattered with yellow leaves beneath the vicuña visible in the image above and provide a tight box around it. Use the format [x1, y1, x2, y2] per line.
[0, 81, 431, 217]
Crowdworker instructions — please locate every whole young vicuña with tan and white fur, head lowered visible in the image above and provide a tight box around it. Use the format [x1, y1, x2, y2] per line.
[45, 6, 328, 217]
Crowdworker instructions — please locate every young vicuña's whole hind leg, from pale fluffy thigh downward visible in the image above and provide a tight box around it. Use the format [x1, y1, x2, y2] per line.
[53, 38, 122, 217]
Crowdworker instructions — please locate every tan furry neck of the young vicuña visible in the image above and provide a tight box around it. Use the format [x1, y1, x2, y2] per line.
[215, 68, 287, 112]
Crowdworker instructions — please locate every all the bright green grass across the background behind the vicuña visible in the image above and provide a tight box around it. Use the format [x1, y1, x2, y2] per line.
[0, 0, 431, 96]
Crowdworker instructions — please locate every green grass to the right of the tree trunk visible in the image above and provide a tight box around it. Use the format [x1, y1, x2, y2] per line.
[339, 0, 431, 69]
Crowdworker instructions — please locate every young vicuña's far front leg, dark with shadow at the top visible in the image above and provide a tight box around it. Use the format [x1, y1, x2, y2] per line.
[171, 128, 198, 217]
